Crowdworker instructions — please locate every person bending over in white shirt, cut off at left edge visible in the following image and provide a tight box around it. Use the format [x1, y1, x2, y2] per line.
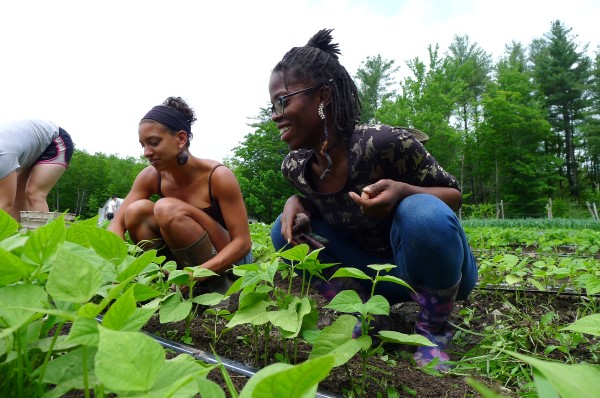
[0, 119, 73, 221]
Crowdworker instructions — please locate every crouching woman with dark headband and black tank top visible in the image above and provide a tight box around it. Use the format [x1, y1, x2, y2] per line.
[108, 97, 252, 300]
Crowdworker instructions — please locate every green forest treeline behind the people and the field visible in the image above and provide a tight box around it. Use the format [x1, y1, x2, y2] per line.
[48, 20, 600, 223]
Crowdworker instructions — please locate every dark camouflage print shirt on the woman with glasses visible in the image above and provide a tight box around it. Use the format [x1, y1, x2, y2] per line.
[281, 125, 460, 257]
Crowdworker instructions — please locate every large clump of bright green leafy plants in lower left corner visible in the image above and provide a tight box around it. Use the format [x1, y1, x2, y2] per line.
[0, 212, 225, 397]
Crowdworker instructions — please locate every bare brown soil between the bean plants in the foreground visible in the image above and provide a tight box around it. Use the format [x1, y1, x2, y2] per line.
[138, 274, 592, 397]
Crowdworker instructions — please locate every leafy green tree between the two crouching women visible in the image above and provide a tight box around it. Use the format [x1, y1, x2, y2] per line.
[226, 108, 294, 223]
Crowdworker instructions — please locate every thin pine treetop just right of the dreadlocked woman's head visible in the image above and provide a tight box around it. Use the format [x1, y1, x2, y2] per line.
[355, 54, 399, 123]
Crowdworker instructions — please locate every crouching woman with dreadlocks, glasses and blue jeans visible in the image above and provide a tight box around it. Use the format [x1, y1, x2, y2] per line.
[269, 29, 477, 370]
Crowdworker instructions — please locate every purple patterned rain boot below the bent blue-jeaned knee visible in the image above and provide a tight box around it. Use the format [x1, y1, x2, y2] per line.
[411, 280, 460, 372]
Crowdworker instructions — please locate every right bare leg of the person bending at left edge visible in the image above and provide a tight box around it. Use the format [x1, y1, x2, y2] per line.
[25, 164, 65, 212]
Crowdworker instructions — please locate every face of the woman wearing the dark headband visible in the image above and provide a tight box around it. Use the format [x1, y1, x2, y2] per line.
[138, 122, 187, 171]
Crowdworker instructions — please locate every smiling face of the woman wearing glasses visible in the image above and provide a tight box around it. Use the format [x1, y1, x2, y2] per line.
[269, 72, 324, 150]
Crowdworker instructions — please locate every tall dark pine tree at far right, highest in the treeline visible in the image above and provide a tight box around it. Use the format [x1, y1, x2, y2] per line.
[532, 21, 591, 198]
